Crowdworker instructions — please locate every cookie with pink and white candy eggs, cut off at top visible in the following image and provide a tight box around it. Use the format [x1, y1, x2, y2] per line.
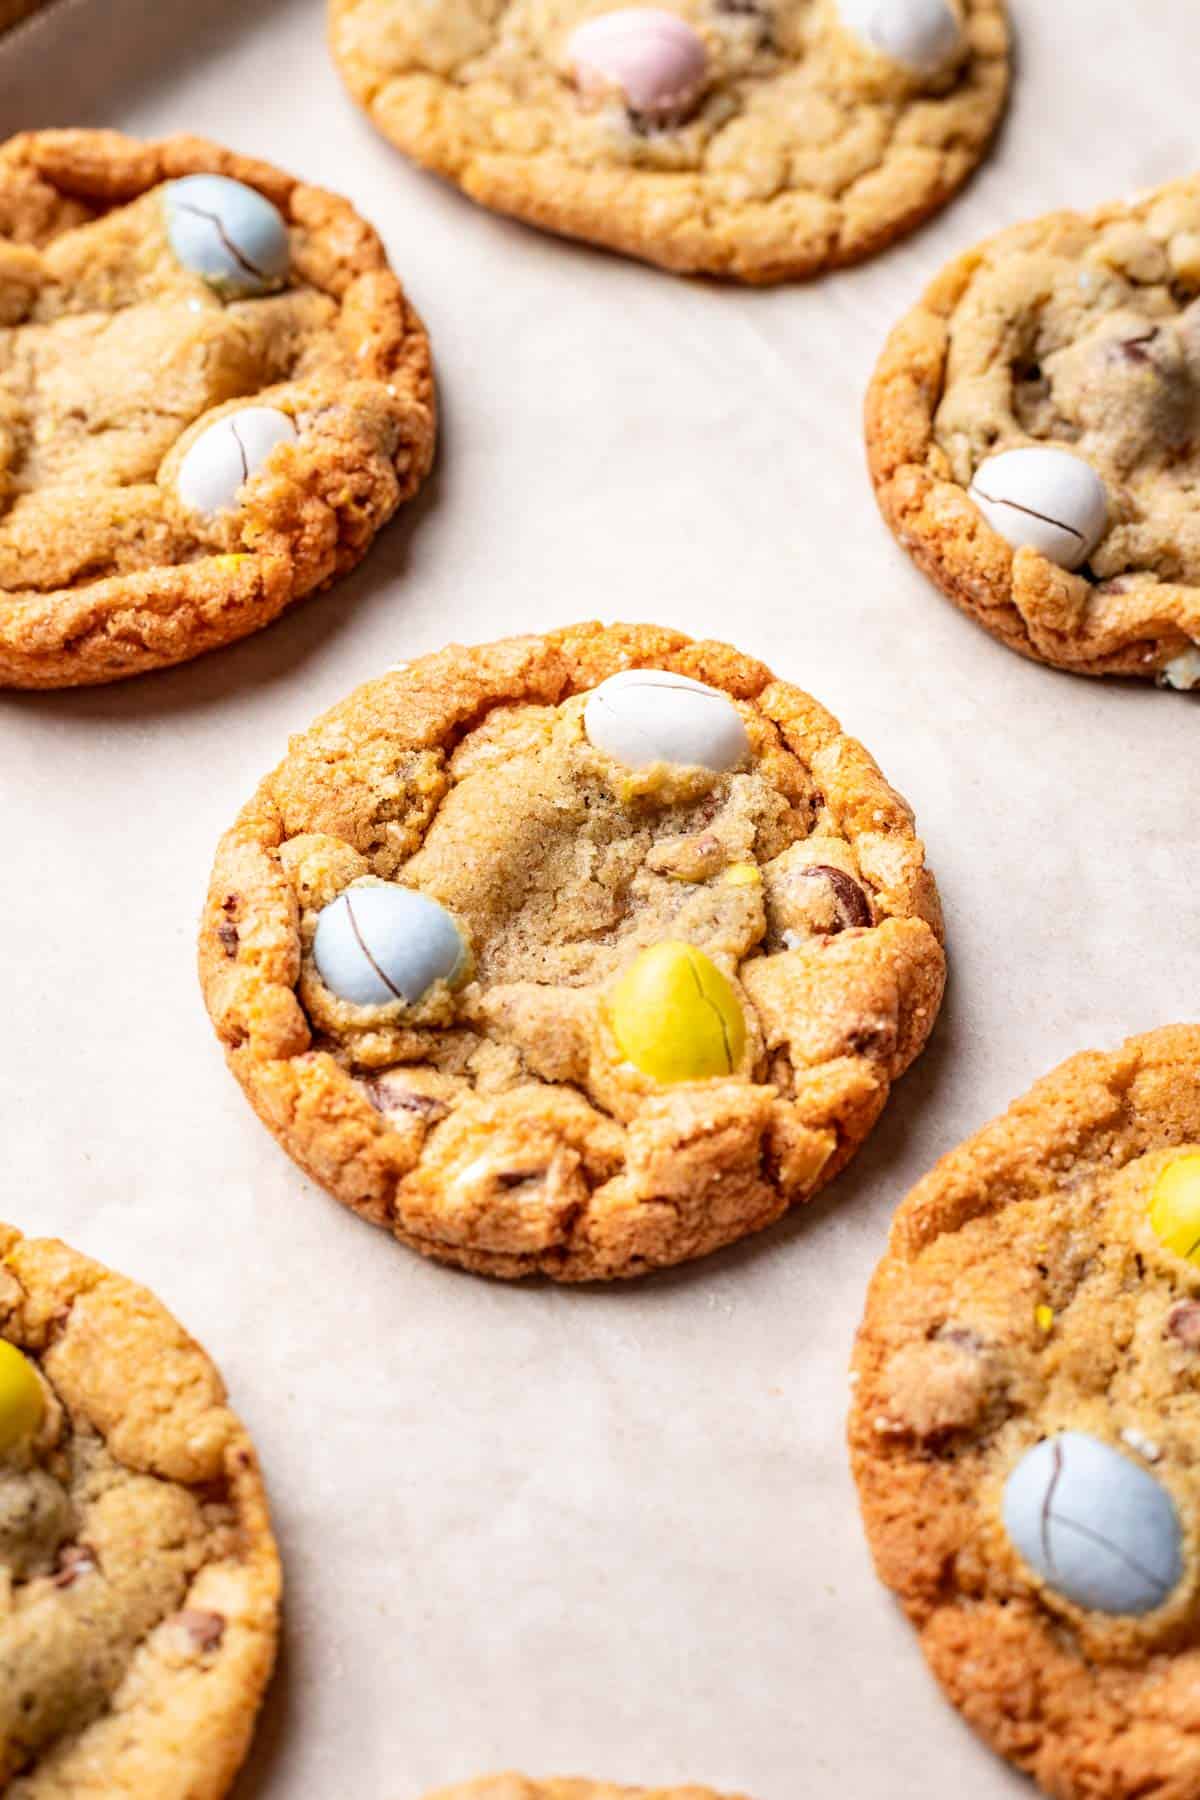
[323, 0, 1009, 283]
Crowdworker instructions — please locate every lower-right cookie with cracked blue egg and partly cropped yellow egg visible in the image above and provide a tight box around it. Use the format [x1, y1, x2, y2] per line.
[849, 1026, 1200, 1800]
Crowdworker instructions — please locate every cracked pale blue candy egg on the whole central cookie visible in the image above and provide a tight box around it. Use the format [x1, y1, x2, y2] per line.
[313, 884, 468, 1006]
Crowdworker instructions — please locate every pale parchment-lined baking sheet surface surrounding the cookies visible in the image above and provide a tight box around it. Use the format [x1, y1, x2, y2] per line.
[0, 0, 1200, 1800]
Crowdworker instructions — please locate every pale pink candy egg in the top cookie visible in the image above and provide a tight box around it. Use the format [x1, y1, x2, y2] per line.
[567, 5, 709, 121]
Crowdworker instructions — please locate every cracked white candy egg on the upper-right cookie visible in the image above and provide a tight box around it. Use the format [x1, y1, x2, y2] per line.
[970, 445, 1108, 569]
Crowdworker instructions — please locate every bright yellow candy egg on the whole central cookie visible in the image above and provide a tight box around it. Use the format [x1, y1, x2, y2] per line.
[608, 943, 747, 1082]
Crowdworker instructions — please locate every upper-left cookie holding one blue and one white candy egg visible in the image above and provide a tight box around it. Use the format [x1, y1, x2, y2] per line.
[0, 131, 435, 688]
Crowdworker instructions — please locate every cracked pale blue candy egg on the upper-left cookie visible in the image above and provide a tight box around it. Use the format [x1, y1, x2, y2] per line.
[164, 175, 291, 299]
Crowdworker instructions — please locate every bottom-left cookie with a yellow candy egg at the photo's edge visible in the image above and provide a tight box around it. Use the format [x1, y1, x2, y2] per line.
[0, 1226, 279, 1800]
